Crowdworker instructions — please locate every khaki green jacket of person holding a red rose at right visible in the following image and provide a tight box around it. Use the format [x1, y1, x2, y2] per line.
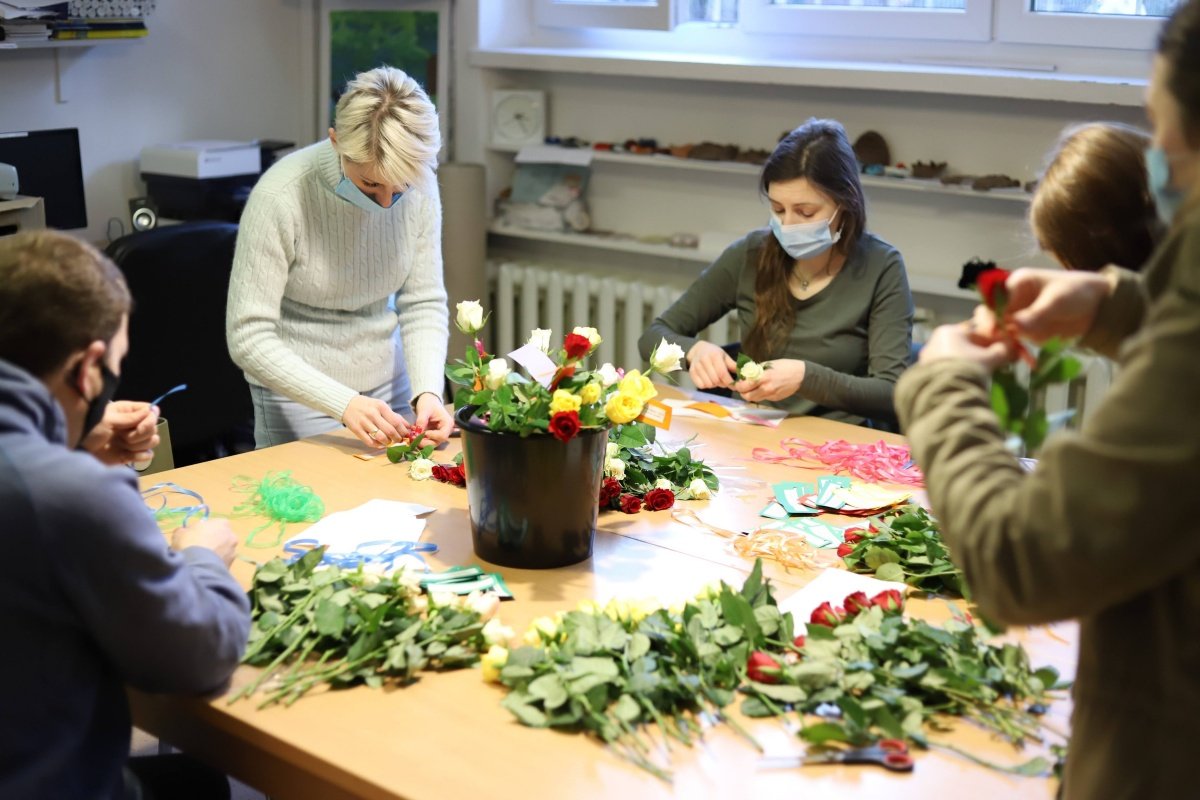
[896, 204, 1200, 800]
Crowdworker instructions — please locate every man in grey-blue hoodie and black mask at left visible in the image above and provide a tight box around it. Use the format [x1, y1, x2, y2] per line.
[0, 231, 250, 799]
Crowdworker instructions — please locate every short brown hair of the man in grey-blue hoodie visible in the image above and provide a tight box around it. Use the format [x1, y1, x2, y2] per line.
[0, 230, 132, 378]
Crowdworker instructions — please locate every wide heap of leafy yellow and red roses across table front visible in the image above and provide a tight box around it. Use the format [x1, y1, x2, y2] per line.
[485, 563, 1063, 780]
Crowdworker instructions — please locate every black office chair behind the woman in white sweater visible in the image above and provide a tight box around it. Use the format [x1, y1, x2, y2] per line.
[106, 222, 254, 467]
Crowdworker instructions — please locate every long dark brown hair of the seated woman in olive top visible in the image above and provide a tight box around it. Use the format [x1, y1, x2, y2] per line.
[742, 119, 866, 361]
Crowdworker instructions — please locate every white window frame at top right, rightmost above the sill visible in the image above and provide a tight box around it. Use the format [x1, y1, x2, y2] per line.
[995, 0, 1166, 52]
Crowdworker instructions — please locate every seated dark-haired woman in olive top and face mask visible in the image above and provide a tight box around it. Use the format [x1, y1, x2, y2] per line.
[638, 119, 913, 423]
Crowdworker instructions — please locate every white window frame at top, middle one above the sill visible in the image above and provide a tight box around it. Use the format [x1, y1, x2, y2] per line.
[738, 0, 993, 42]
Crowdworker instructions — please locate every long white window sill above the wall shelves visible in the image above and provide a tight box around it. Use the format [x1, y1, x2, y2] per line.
[470, 47, 1146, 107]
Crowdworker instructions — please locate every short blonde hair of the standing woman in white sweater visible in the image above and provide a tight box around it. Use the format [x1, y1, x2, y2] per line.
[334, 66, 442, 186]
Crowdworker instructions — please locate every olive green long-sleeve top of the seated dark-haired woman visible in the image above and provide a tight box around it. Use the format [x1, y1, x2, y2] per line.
[638, 229, 913, 425]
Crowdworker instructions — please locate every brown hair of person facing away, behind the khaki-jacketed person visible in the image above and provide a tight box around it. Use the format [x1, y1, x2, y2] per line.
[1030, 122, 1163, 271]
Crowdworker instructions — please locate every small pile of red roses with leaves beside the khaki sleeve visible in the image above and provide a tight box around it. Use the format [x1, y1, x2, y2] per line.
[838, 505, 971, 599]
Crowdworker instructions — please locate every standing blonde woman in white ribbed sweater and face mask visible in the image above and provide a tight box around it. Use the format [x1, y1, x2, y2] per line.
[226, 67, 452, 447]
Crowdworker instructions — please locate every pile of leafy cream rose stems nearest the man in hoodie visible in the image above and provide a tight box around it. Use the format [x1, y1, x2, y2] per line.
[229, 548, 487, 708]
